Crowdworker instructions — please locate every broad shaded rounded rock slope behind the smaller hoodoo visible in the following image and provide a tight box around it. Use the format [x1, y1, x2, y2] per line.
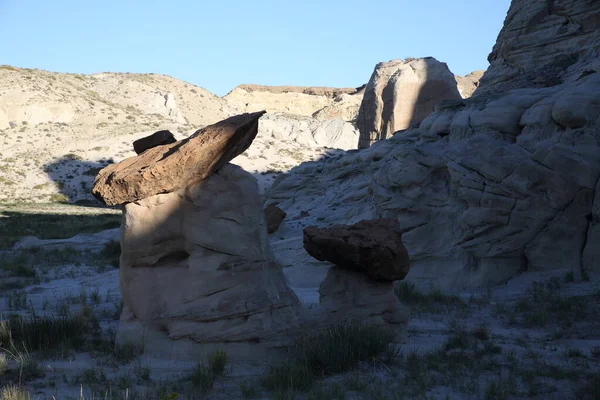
[266, 74, 600, 287]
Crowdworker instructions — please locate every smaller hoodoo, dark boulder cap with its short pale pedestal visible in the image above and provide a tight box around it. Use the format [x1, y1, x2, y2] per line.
[303, 219, 410, 339]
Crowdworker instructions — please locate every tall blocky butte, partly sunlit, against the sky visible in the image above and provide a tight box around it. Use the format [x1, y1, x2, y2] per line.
[357, 57, 461, 148]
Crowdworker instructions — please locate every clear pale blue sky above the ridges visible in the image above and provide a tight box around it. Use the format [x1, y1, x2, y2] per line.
[0, 0, 510, 95]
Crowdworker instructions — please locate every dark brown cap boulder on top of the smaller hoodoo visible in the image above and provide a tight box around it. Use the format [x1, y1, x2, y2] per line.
[304, 218, 410, 281]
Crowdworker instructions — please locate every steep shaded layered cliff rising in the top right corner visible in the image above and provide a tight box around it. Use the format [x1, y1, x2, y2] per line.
[475, 0, 600, 95]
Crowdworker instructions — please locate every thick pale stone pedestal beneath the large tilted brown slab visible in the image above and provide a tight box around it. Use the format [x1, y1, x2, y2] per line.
[120, 164, 299, 357]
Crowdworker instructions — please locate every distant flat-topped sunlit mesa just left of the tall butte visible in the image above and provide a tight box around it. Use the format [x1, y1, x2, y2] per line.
[223, 85, 363, 121]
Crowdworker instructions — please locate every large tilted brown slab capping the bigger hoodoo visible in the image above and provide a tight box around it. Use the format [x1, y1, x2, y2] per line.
[92, 111, 265, 206]
